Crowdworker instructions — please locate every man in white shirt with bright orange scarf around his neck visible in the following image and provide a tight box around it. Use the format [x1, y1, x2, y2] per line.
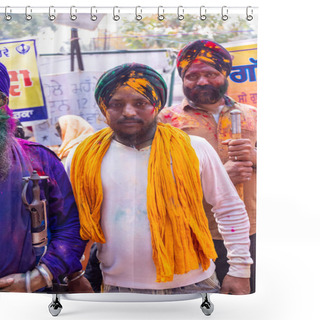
[67, 63, 252, 294]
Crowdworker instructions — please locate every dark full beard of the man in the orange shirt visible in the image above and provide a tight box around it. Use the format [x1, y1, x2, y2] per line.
[183, 79, 228, 105]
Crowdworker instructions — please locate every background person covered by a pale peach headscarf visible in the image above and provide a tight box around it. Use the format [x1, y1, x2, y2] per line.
[55, 115, 94, 164]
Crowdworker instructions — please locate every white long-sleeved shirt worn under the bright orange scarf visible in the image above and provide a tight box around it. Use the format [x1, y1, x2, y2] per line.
[67, 136, 252, 290]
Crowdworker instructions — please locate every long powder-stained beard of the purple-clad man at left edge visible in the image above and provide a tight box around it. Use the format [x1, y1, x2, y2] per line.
[0, 109, 13, 182]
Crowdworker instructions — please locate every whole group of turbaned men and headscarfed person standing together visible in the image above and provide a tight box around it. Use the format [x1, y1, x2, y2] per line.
[0, 40, 257, 294]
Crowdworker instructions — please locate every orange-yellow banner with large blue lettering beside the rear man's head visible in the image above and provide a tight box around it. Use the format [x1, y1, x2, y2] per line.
[226, 44, 257, 107]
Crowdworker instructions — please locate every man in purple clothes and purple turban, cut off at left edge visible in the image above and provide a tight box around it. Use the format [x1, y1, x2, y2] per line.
[0, 63, 92, 292]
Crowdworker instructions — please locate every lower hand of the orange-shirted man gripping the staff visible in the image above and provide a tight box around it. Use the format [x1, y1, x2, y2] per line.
[224, 160, 253, 185]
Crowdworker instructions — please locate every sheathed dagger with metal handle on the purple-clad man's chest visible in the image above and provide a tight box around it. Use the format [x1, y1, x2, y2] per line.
[21, 170, 49, 248]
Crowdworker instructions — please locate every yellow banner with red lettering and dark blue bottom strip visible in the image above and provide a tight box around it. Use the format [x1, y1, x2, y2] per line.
[0, 40, 47, 121]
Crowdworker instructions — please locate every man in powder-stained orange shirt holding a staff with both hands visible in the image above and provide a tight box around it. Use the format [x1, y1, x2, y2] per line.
[159, 40, 256, 292]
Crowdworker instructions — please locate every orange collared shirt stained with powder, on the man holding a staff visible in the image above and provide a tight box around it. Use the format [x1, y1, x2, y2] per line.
[159, 96, 257, 240]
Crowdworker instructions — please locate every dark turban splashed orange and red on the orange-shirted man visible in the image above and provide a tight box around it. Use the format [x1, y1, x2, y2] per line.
[177, 40, 232, 78]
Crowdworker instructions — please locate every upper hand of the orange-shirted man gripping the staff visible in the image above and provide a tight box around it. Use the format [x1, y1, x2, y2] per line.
[222, 139, 257, 165]
